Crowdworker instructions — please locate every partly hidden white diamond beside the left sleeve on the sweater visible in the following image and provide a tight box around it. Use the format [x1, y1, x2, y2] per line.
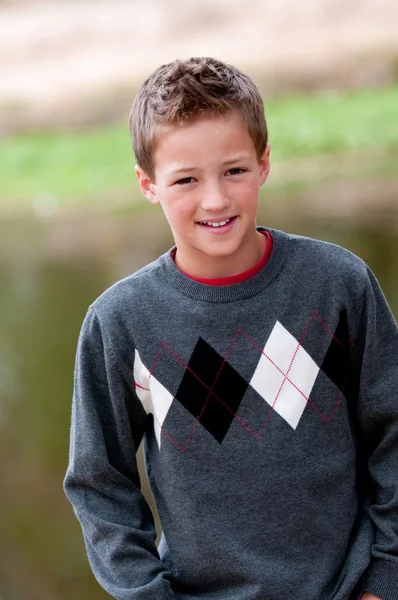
[134, 350, 174, 449]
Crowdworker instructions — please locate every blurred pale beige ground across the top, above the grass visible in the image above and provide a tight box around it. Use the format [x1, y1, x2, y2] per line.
[0, 0, 398, 134]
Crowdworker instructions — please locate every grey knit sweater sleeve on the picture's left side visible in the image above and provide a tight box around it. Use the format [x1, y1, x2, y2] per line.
[64, 307, 175, 600]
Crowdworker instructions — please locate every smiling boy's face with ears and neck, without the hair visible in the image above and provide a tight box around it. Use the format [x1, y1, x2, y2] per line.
[136, 112, 270, 277]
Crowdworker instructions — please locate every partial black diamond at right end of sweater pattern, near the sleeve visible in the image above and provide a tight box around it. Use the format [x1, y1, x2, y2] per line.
[321, 309, 349, 390]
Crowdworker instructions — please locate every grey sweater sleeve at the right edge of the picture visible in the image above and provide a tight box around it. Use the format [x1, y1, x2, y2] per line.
[357, 268, 398, 600]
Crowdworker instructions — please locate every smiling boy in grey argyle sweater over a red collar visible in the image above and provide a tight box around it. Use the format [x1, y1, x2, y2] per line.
[65, 58, 398, 600]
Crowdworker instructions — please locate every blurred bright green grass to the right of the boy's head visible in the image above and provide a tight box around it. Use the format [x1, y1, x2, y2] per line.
[266, 85, 398, 159]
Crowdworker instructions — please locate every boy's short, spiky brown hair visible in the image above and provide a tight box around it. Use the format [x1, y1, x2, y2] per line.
[129, 57, 268, 180]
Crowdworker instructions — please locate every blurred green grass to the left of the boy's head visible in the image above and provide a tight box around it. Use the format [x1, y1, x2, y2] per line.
[0, 124, 140, 202]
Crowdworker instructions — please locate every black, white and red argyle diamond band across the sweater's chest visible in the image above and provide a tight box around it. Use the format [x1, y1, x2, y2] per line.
[134, 311, 352, 451]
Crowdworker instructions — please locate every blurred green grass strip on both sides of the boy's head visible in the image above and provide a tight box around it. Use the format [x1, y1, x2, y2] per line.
[0, 85, 398, 205]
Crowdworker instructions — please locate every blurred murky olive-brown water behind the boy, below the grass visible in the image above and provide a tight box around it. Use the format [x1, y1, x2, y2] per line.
[0, 203, 398, 600]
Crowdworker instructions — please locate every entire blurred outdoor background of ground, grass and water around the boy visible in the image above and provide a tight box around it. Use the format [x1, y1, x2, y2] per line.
[0, 0, 398, 600]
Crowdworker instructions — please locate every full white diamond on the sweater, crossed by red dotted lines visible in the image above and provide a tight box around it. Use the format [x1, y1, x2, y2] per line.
[250, 321, 319, 429]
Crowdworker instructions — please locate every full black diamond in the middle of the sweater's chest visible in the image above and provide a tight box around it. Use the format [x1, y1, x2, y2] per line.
[176, 338, 248, 444]
